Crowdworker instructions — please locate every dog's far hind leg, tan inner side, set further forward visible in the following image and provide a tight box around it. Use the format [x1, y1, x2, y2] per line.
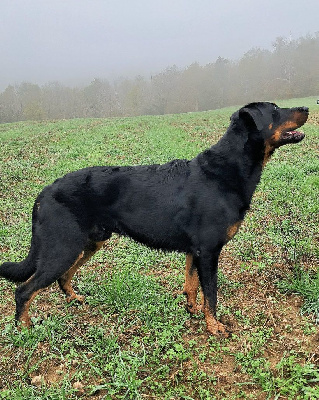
[58, 241, 105, 303]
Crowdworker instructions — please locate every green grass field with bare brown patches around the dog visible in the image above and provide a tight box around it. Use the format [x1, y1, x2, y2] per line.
[0, 98, 319, 400]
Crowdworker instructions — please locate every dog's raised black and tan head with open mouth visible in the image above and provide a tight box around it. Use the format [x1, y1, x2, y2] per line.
[236, 102, 309, 150]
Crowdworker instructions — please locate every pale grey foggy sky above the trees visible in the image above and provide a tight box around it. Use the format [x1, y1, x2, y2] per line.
[0, 0, 319, 90]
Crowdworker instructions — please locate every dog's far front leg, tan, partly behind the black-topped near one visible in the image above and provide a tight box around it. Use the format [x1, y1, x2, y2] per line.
[183, 254, 200, 314]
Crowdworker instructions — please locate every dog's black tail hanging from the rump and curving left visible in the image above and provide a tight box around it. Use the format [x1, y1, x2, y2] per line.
[0, 200, 37, 283]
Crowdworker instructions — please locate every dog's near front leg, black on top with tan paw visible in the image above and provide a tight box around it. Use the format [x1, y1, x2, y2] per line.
[194, 251, 228, 337]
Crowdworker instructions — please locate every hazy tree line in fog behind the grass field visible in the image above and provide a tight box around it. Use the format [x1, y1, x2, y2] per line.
[0, 32, 319, 123]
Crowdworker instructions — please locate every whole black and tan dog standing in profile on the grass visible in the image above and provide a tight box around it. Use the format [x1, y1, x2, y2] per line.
[0, 103, 308, 335]
